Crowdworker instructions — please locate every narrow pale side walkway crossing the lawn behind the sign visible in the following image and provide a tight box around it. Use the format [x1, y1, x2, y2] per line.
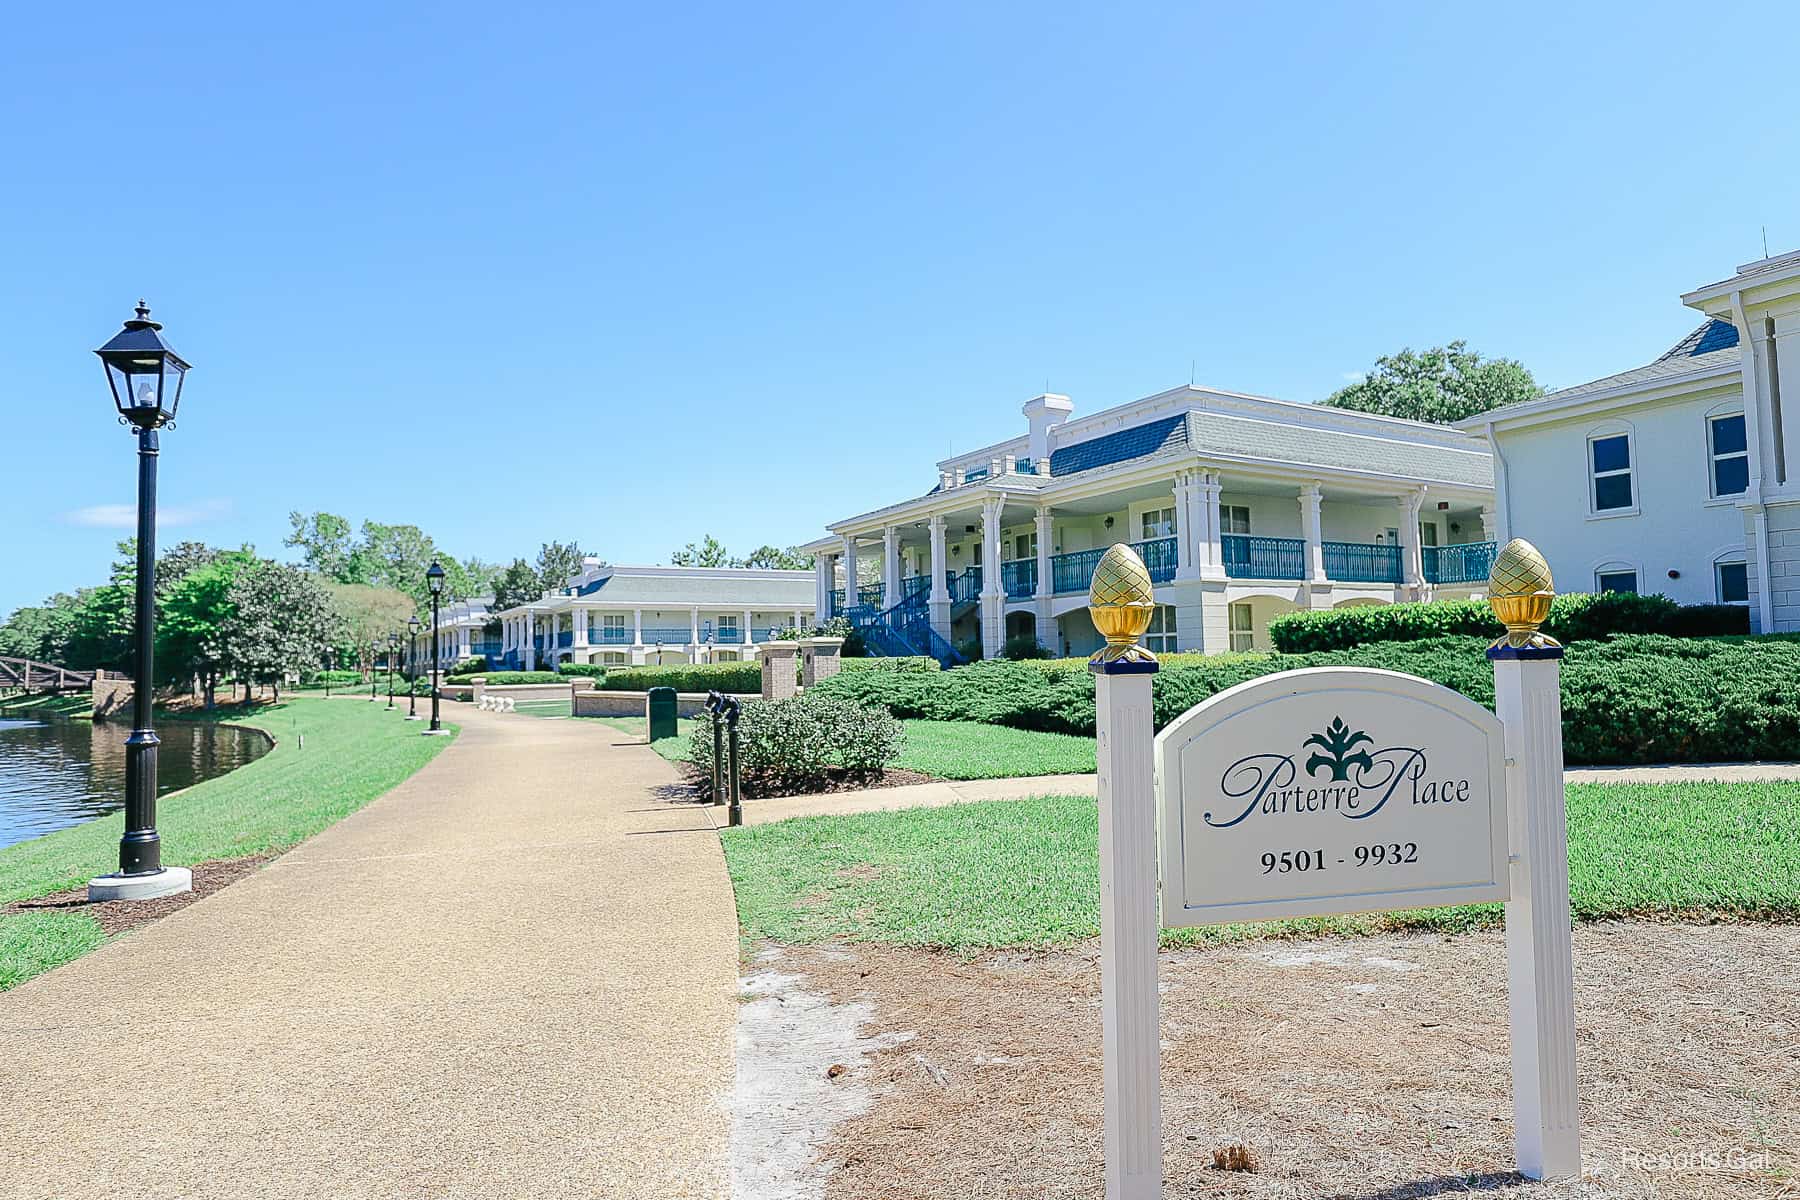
[711, 763, 1800, 826]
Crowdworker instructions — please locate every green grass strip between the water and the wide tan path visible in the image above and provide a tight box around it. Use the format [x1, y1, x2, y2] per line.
[0, 698, 455, 991]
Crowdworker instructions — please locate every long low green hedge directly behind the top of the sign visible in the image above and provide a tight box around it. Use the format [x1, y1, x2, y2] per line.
[817, 633, 1800, 763]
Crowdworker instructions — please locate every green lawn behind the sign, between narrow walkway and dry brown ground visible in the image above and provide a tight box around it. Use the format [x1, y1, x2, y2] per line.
[722, 783, 1800, 950]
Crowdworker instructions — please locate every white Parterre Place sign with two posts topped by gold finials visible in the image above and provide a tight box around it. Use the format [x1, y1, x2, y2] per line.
[1089, 542, 1580, 1200]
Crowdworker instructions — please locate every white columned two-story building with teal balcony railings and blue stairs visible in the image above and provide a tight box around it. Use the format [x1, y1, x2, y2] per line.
[805, 387, 1494, 658]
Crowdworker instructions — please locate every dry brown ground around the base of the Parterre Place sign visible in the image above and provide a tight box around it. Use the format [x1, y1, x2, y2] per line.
[760, 923, 1800, 1200]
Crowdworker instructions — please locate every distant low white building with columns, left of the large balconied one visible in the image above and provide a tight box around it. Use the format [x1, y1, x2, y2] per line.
[488, 558, 817, 671]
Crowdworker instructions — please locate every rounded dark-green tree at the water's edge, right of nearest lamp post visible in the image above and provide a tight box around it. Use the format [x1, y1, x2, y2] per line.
[212, 560, 340, 700]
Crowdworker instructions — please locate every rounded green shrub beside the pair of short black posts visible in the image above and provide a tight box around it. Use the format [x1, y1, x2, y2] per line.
[688, 694, 905, 799]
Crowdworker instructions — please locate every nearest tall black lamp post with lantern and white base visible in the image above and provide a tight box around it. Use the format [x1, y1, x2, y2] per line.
[88, 300, 191, 900]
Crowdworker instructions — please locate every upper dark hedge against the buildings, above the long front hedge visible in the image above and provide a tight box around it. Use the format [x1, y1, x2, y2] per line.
[1269, 592, 1750, 655]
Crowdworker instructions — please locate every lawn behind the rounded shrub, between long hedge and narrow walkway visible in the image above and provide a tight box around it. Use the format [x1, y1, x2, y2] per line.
[594, 716, 1094, 779]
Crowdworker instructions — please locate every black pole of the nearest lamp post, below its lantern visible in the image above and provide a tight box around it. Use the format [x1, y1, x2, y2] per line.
[119, 430, 162, 874]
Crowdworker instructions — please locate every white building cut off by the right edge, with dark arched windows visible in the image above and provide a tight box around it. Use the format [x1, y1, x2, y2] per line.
[1460, 254, 1800, 631]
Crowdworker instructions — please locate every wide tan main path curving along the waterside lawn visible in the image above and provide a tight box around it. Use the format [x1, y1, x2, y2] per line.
[0, 705, 738, 1200]
